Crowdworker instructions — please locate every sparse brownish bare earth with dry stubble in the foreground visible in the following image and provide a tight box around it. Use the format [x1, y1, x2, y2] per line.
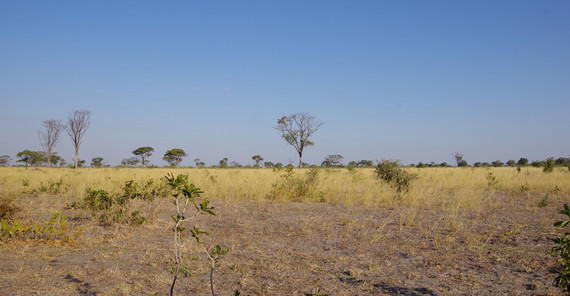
[0, 196, 561, 295]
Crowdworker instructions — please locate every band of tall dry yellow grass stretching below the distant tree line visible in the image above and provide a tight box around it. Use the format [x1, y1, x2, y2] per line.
[0, 167, 570, 207]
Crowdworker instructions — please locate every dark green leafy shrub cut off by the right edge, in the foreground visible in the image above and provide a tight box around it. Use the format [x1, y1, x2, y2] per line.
[550, 204, 570, 295]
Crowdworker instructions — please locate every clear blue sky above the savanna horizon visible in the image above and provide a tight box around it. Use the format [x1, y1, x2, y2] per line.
[0, 0, 570, 165]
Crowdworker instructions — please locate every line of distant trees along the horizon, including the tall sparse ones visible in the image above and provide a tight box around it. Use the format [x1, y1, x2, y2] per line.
[0, 110, 570, 168]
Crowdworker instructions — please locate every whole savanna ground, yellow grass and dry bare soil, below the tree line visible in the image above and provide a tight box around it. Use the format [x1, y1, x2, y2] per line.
[0, 167, 570, 295]
